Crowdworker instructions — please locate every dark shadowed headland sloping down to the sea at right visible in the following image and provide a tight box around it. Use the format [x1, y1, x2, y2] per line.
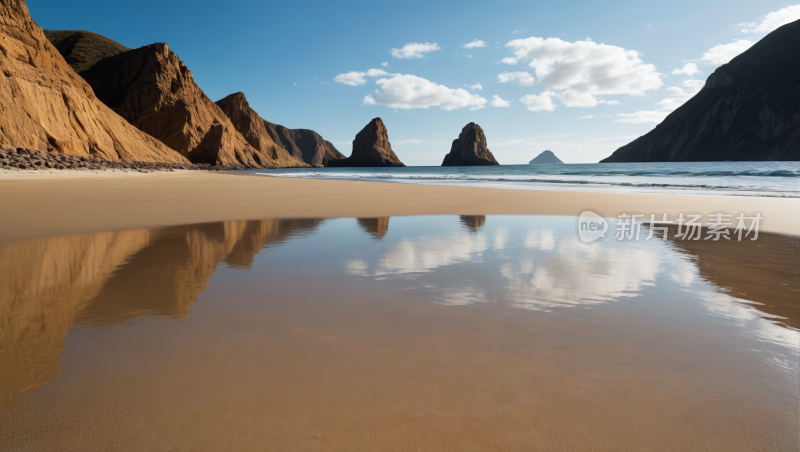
[603, 21, 800, 162]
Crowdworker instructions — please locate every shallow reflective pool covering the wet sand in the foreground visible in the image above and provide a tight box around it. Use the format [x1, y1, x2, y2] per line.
[0, 216, 800, 451]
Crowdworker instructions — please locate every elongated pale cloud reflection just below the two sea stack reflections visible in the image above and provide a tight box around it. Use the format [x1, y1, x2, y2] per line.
[345, 233, 487, 276]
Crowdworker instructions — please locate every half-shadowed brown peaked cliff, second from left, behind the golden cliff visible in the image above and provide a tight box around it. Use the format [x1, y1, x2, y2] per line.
[75, 43, 275, 168]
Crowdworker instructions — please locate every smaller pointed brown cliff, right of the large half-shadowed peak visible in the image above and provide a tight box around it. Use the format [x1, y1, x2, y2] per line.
[212, 92, 308, 167]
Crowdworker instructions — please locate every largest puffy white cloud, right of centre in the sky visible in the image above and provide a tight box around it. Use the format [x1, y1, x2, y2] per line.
[502, 37, 663, 107]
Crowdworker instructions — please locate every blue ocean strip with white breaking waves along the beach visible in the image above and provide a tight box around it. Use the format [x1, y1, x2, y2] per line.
[255, 162, 800, 198]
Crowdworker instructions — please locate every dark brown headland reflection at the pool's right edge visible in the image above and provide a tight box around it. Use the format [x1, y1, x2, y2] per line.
[670, 230, 800, 330]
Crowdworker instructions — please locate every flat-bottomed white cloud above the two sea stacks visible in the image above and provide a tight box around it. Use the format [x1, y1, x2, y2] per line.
[364, 74, 486, 110]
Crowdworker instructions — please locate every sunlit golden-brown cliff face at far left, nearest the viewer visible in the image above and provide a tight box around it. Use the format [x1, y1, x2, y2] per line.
[0, 0, 188, 163]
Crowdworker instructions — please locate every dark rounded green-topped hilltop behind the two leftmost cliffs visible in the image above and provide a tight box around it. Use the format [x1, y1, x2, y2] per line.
[42, 30, 130, 75]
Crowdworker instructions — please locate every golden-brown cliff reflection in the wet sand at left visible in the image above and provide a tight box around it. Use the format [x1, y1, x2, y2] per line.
[0, 220, 321, 411]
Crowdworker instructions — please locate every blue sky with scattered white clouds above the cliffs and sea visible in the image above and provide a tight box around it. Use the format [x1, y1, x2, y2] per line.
[28, 0, 800, 165]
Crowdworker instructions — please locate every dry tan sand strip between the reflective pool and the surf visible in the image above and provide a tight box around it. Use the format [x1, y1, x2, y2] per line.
[0, 170, 800, 243]
